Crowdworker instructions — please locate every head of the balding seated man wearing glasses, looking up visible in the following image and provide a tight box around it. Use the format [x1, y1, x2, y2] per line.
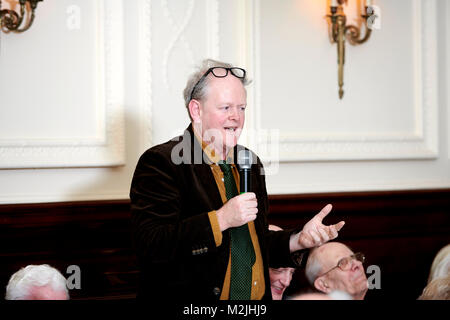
[305, 242, 368, 300]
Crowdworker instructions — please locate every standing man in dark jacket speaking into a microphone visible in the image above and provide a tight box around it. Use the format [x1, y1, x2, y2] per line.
[130, 60, 344, 301]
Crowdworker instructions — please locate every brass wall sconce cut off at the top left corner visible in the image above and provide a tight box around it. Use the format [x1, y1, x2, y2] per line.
[0, 0, 43, 33]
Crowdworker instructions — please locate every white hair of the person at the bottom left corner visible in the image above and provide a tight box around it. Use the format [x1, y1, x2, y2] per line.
[5, 264, 69, 300]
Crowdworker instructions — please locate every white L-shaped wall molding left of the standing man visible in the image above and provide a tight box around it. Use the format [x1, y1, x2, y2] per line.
[0, 0, 125, 168]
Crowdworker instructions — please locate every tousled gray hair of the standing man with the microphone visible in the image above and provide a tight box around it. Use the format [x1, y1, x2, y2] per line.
[183, 59, 250, 120]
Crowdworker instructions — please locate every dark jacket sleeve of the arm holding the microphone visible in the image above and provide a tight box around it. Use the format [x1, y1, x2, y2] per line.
[130, 148, 216, 263]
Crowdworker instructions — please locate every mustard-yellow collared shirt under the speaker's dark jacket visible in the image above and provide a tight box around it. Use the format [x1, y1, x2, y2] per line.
[195, 134, 265, 300]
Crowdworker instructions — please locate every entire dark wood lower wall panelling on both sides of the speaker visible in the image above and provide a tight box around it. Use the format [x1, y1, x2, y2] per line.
[0, 189, 450, 299]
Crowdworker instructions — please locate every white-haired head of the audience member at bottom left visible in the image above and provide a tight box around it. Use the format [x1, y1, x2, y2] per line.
[5, 264, 69, 300]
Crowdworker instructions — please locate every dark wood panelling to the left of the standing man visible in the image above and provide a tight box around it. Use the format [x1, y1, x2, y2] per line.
[0, 200, 138, 299]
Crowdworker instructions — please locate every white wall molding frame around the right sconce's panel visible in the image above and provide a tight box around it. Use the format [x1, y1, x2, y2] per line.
[244, 0, 438, 162]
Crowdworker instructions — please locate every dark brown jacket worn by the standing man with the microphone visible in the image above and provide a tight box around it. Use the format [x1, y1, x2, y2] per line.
[130, 125, 307, 301]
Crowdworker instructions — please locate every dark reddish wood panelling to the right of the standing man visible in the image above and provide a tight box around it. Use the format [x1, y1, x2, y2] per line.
[269, 189, 450, 299]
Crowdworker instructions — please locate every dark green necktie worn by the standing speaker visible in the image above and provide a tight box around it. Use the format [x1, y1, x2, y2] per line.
[219, 163, 255, 300]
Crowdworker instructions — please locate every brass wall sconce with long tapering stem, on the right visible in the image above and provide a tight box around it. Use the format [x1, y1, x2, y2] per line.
[327, 0, 376, 99]
